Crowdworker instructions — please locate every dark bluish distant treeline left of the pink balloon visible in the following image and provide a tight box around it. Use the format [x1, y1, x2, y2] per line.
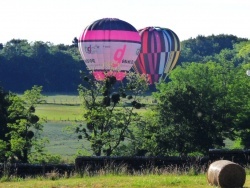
[0, 39, 85, 93]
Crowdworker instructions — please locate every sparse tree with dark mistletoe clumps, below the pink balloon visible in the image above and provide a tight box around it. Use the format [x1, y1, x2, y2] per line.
[76, 73, 148, 156]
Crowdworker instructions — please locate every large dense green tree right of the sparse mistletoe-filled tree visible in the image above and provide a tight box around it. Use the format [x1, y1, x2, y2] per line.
[139, 62, 249, 155]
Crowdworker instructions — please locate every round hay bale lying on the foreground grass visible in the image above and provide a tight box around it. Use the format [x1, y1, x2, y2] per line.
[207, 160, 246, 188]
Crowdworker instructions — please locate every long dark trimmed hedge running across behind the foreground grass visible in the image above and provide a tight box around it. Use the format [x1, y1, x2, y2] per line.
[0, 149, 250, 177]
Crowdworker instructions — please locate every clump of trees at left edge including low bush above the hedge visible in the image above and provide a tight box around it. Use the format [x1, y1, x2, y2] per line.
[0, 86, 60, 163]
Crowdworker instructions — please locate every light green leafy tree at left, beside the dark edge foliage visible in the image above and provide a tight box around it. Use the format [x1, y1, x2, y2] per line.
[7, 86, 42, 163]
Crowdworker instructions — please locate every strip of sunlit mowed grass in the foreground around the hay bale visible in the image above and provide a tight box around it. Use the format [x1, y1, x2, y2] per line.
[0, 174, 250, 188]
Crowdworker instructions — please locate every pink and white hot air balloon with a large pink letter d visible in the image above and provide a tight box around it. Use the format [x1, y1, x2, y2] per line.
[78, 18, 141, 80]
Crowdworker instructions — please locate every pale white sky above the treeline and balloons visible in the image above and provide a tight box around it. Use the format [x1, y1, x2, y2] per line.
[0, 0, 250, 45]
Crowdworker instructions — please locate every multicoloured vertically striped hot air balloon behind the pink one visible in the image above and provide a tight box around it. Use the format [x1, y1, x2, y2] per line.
[133, 27, 181, 84]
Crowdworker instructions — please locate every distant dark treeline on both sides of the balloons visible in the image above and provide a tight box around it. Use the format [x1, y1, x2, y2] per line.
[0, 34, 248, 93]
